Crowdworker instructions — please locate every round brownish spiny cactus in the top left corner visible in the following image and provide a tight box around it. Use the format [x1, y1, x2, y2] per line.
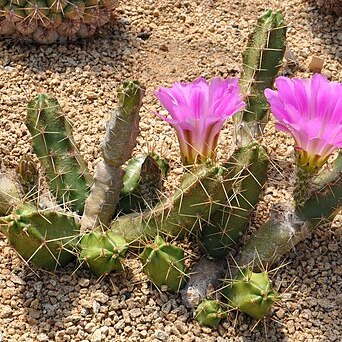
[0, 0, 116, 44]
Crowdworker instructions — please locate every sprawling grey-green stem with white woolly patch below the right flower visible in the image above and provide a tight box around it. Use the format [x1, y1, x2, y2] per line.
[237, 158, 342, 268]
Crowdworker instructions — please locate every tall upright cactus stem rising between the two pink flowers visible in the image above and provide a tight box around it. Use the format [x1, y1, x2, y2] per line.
[235, 10, 286, 144]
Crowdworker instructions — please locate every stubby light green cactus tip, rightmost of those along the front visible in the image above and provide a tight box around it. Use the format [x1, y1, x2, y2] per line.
[221, 268, 278, 319]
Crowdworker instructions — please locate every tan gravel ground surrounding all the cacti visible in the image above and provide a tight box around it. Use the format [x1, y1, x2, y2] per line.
[0, 0, 342, 342]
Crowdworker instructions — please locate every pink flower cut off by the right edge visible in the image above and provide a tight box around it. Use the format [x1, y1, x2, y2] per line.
[265, 74, 342, 172]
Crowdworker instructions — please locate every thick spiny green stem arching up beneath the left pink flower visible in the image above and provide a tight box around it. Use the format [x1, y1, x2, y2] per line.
[111, 144, 260, 243]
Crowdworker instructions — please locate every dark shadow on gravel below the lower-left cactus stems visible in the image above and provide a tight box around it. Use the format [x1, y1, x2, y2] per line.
[9, 262, 135, 341]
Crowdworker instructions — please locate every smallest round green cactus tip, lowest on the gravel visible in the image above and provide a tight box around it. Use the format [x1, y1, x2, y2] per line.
[195, 300, 227, 328]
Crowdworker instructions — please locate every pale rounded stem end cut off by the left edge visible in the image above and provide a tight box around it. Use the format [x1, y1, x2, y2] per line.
[0, 173, 22, 216]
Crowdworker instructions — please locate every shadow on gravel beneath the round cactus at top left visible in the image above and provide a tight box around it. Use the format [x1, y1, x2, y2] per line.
[0, 17, 141, 74]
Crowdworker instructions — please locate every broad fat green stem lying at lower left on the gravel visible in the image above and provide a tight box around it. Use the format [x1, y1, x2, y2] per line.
[0, 204, 79, 271]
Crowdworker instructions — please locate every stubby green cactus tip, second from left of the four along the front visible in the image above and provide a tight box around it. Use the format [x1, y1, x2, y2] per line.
[140, 236, 186, 292]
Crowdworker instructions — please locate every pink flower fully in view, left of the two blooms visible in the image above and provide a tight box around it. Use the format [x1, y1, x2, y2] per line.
[155, 77, 245, 165]
